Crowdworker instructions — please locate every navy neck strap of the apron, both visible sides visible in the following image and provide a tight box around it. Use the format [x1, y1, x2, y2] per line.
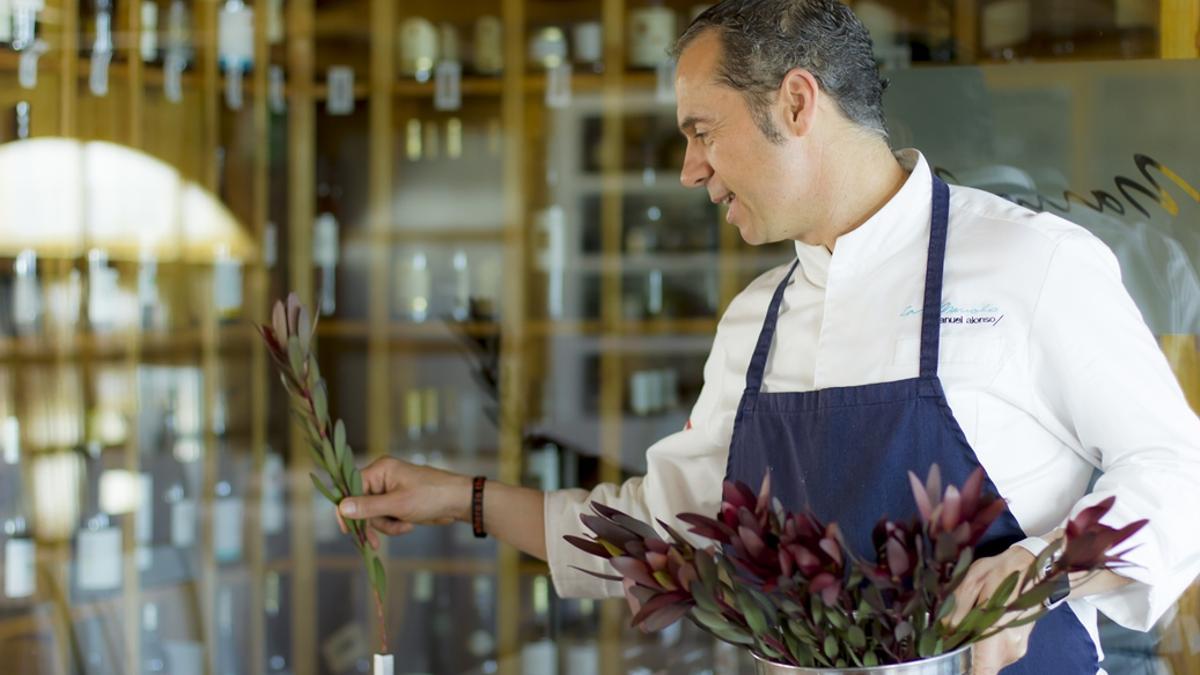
[746, 175, 950, 393]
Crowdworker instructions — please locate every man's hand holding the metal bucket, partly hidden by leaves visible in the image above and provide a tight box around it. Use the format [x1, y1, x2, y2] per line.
[949, 546, 1033, 675]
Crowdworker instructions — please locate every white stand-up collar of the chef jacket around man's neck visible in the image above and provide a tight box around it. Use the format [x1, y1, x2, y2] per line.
[796, 148, 932, 288]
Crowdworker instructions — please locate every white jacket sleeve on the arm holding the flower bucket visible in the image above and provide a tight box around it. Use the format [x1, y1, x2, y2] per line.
[1030, 223, 1200, 631]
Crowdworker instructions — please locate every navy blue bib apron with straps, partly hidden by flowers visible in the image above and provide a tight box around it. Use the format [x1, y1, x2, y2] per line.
[726, 177, 1099, 675]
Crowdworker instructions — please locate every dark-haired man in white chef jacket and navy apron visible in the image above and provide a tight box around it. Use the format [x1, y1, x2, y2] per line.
[341, 0, 1200, 674]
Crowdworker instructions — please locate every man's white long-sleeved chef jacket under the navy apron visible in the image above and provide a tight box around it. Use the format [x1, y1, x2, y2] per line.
[545, 145, 1200, 643]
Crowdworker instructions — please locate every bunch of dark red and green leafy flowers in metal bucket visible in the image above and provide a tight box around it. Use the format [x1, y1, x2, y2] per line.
[565, 466, 1146, 668]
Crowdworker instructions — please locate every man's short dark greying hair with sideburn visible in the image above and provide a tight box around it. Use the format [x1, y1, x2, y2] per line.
[673, 0, 888, 143]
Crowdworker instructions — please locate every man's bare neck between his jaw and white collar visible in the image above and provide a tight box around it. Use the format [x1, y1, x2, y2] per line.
[804, 139, 908, 252]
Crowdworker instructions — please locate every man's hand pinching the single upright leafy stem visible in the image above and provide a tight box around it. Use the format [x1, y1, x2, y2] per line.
[337, 458, 470, 549]
